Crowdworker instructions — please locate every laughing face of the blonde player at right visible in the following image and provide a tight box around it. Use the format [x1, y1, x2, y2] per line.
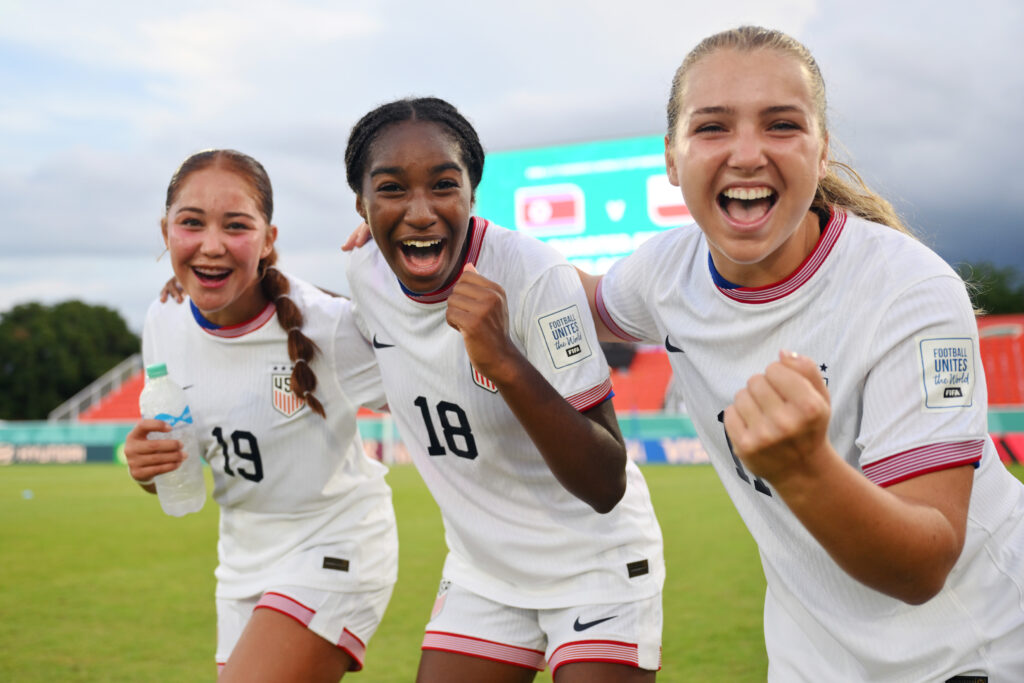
[666, 48, 828, 287]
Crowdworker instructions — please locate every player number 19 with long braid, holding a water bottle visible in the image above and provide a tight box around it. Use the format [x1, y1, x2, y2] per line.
[125, 150, 398, 682]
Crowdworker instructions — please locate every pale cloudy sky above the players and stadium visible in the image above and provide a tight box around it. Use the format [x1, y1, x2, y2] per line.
[0, 0, 1024, 331]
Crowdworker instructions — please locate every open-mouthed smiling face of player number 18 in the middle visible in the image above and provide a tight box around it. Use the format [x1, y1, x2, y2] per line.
[355, 121, 473, 294]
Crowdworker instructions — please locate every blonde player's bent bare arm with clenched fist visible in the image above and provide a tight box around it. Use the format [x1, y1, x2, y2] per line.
[725, 352, 974, 604]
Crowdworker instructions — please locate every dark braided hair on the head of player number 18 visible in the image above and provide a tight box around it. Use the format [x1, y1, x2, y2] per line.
[345, 97, 483, 195]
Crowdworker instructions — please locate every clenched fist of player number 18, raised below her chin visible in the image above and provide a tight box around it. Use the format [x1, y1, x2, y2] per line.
[445, 263, 518, 381]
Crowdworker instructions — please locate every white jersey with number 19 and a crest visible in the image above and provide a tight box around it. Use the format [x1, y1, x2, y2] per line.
[142, 278, 397, 598]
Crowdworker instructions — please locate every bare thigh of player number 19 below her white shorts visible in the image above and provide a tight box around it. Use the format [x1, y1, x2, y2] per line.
[218, 609, 352, 683]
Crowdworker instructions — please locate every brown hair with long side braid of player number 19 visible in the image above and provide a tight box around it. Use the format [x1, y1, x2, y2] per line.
[164, 150, 325, 417]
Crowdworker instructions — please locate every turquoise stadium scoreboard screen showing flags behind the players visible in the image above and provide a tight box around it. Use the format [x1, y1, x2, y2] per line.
[476, 135, 692, 273]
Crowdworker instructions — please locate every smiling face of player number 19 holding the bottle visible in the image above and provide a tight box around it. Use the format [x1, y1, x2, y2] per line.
[161, 166, 278, 325]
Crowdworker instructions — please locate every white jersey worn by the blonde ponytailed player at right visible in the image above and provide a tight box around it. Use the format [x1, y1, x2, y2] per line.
[598, 211, 1024, 682]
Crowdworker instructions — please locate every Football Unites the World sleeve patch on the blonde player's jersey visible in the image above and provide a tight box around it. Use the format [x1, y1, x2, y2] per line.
[918, 337, 975, 409]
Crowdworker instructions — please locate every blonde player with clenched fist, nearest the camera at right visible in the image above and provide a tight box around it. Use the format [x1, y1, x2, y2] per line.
[585, 27, 1024, 683]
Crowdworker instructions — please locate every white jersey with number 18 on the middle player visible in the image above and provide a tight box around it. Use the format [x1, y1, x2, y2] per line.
[348, 218, 665, 607]
